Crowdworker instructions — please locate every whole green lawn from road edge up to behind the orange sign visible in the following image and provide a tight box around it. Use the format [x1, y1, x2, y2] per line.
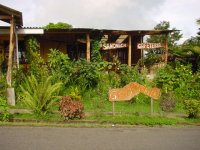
[5, 94, 200, 127]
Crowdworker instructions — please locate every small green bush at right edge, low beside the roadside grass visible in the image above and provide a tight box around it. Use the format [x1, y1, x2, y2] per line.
[184, 100, 200, 118]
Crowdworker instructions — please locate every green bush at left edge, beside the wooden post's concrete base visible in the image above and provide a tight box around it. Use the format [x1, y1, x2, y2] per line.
[0, 95, 10, 121]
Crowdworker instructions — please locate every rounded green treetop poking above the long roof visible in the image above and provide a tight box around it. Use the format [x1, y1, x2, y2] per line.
[43, 22, 72, 30]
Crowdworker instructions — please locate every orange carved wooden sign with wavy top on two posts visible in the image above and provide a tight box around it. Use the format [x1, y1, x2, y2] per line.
[109, 82, 161, 101]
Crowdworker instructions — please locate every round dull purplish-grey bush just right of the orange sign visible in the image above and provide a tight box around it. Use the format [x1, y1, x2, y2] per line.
[160, 93, 176, 112]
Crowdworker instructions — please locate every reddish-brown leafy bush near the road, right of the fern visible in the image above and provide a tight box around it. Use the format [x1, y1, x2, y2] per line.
[60, 96, 84, 119]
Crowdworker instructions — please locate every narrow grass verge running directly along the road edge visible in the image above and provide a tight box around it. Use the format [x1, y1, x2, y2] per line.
[0, 113, 200, 127]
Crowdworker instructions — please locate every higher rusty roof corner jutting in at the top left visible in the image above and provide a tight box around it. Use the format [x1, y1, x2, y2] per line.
[0, 4, 23, 26]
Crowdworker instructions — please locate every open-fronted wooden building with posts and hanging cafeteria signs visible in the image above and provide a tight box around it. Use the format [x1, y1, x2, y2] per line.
[0, 5, 173, 66]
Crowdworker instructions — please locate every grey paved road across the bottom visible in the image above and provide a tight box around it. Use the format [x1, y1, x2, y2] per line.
[0, 127, 200, 150]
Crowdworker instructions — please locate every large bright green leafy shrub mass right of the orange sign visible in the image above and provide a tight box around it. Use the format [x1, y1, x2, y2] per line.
[155, 62, 200, 103]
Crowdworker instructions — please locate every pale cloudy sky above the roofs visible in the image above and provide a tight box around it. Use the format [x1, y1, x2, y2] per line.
[0, 0, 200, 41]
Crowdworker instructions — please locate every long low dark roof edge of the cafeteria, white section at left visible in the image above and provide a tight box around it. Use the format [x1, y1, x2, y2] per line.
[0, 27, 175, 36]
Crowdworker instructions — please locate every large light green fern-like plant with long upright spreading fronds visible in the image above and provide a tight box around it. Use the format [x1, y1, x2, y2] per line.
[20, 75, 61, 116]
